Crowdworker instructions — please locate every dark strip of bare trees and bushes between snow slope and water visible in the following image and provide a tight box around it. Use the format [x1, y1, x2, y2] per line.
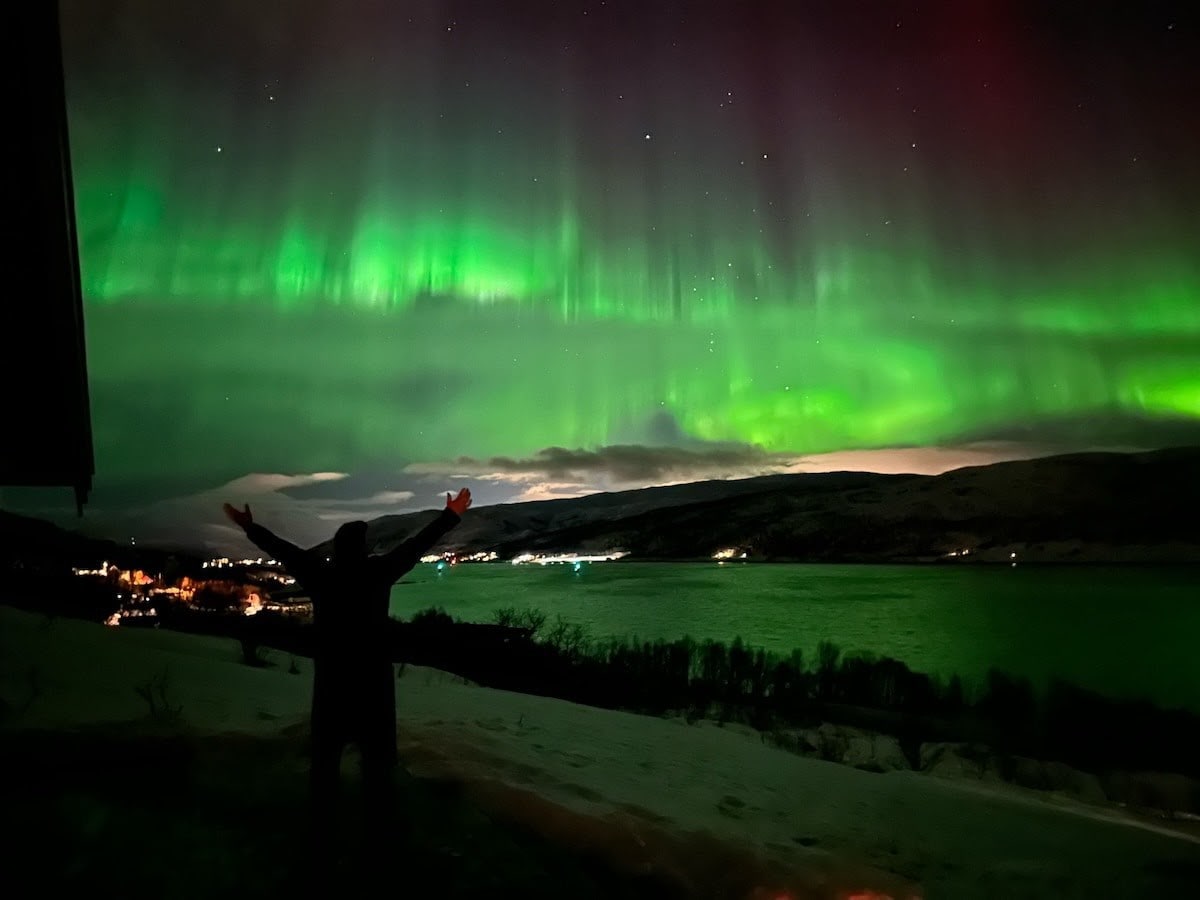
[0, 598, 1200, 821]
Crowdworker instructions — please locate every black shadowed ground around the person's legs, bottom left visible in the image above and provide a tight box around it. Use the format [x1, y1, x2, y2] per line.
[0, 731, 700, 900]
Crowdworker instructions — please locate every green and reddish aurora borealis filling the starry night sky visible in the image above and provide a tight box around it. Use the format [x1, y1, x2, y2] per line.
[49, 0, 1200, 525]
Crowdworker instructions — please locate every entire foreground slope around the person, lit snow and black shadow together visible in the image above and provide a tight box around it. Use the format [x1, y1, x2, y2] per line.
[0, 607, 1200, 900]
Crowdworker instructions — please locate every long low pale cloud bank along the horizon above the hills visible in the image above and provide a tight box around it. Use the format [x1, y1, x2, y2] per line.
[37, 440, 1118, 554]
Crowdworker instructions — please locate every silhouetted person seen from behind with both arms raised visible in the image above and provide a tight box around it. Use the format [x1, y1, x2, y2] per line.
[224, 488, 470, 868]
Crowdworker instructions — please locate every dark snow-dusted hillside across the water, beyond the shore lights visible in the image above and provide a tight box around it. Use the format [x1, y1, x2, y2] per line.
[371, 448, 1200, 563]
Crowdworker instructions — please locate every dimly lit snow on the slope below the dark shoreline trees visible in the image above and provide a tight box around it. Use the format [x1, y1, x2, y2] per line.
[0, 607, 1200, 899]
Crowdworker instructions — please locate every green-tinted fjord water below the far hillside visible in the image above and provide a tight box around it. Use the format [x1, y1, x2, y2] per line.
[391, 563, 1200, 712]
